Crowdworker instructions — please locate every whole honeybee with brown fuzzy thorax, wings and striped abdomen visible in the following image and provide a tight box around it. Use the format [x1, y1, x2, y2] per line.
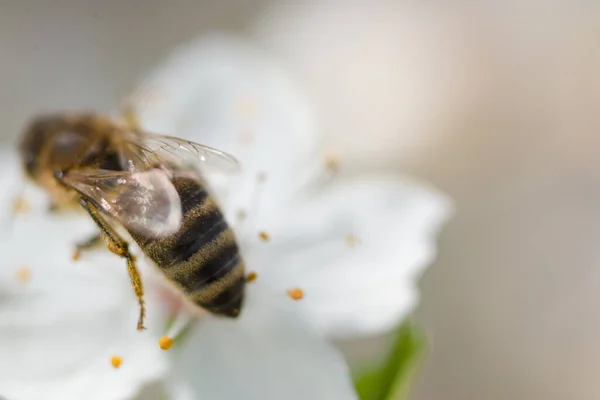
[20, 113, 246, 330]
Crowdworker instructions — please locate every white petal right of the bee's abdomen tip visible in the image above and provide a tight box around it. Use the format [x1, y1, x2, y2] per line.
[247, 177, 450, 337]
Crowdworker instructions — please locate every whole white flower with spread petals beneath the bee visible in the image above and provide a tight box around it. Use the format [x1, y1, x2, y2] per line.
[0, 35, 448, 400]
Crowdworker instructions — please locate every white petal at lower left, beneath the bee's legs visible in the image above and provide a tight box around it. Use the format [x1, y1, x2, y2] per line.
[0, 161, 167, 400]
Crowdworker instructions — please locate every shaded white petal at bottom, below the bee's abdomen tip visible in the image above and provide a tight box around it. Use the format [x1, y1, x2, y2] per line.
[166, 293, 356, 400]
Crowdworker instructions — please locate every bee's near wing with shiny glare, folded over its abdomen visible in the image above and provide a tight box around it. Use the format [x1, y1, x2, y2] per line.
[61, 168, 182, 237]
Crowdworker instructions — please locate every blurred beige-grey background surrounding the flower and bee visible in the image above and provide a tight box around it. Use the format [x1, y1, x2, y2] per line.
[0, 0, 600, 400]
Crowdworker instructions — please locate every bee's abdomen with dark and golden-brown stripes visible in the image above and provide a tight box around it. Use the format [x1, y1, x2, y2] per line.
[130, 177, 246, 317]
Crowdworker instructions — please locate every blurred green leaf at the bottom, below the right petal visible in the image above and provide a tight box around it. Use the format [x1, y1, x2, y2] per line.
[354, 322, 425, 400]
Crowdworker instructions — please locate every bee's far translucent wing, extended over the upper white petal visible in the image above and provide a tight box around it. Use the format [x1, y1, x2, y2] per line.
[134, 133, 241, 174]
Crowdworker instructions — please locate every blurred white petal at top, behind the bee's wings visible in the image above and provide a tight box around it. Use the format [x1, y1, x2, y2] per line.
[133, 36, 317, 220]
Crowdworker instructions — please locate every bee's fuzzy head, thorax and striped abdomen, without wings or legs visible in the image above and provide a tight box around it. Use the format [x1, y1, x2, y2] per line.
[20, 114, 245, 317]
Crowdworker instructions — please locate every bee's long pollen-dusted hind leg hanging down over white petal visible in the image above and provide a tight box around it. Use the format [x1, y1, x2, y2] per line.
[79, 199, 146, 330]
